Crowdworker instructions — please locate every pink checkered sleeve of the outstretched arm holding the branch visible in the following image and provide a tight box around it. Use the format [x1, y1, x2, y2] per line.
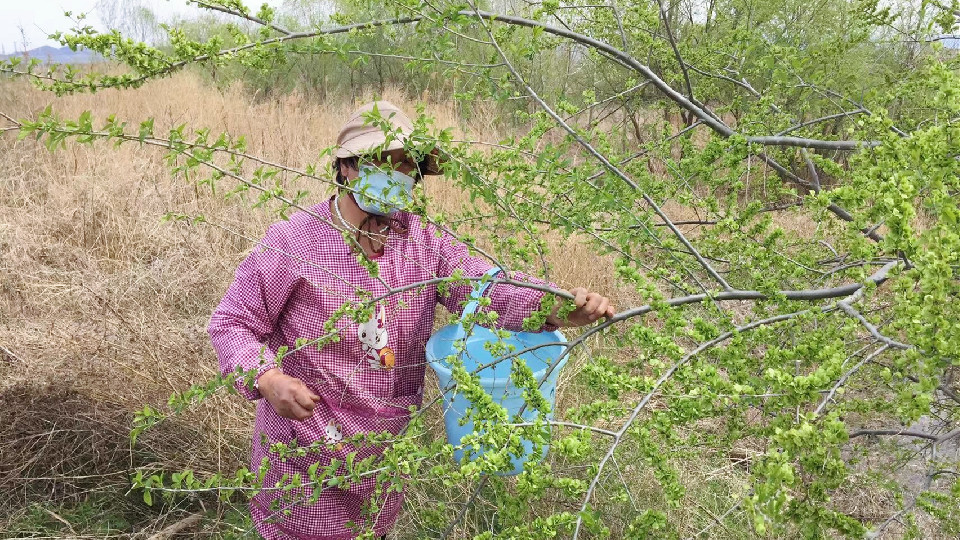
[430, 227, 557, 332]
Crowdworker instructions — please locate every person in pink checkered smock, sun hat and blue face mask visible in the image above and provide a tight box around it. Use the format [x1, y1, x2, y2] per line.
[208, 101, 614, 540]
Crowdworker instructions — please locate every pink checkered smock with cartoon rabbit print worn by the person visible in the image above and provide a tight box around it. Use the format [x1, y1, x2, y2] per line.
[208, 201, 554, 540]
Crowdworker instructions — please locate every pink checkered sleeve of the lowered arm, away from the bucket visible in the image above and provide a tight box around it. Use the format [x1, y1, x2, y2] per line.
[207, 224, 297, 399]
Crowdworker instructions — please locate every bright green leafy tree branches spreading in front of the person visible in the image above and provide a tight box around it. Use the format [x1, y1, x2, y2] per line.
[0, 0, 960, 538]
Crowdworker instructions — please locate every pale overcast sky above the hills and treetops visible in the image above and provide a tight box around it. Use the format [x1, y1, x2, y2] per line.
[0, 0, 282, 54]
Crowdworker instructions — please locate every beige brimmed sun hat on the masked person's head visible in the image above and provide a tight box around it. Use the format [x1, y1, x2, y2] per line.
[334, 101, 440, 174]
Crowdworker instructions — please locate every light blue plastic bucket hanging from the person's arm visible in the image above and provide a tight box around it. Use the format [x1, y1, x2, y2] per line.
[426, 268, 567, 475]
